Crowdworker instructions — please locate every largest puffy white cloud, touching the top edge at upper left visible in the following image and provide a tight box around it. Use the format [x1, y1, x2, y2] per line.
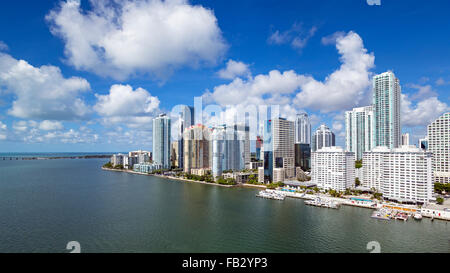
[47, 0, 227, 80]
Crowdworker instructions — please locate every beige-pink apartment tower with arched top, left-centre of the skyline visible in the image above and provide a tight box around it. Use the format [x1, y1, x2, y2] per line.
[183, 125, 212, 173]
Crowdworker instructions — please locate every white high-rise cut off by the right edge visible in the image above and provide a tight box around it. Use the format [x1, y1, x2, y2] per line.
[428, 112, 450, 183]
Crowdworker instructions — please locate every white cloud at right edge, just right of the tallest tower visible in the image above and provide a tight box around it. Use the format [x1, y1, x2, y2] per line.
[401, 94, 450, 127]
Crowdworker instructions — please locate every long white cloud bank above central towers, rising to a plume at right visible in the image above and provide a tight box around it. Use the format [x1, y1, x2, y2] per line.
[204, 32, 375, 113]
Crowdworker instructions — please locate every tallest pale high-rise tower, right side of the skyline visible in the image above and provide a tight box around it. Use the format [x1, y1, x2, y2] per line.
[373, 71, 401, 149]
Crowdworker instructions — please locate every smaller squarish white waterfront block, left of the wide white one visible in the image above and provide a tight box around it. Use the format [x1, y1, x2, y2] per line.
[311, 147, 355, 191]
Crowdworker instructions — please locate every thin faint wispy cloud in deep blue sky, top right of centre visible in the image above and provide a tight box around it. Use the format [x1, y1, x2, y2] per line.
[267, 23, 317, 50]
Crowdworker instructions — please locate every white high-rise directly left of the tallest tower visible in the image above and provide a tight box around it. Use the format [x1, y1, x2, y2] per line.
[345, 106, 374, 160]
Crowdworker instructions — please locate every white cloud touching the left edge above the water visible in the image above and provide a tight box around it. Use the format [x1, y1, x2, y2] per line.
[0, 53, 90, 120]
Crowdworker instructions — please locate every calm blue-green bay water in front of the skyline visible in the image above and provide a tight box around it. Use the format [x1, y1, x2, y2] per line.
[0, 159, 450, 252]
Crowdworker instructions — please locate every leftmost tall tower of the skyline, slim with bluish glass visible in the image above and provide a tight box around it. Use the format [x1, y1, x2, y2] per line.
[153, 114, 171, 169]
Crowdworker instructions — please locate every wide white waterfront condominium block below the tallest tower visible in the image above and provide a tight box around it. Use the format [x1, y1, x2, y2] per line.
[362, 146, 433, 204]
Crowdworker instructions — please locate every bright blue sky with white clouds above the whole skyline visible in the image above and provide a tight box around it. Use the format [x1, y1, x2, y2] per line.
[0, 0, 450, 152]
